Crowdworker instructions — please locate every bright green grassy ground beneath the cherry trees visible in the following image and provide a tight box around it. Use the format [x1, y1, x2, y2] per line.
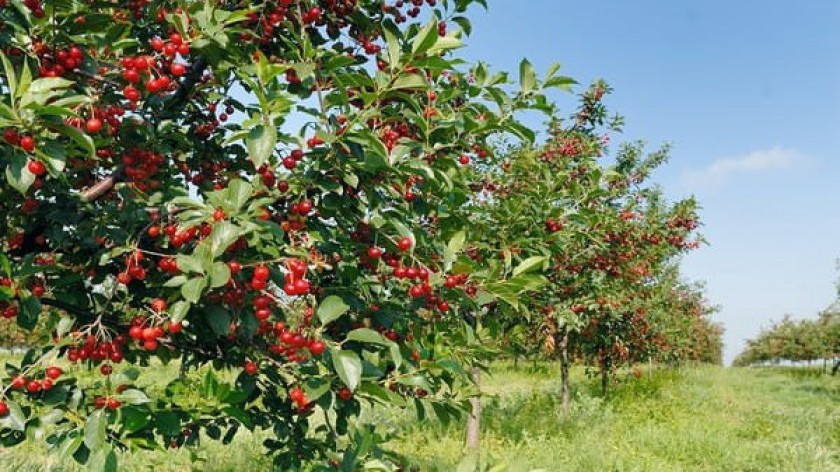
[0, 364, 840, 472]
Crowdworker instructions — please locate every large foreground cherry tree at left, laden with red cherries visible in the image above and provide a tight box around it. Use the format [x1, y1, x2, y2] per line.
[0, 0, 562, 469]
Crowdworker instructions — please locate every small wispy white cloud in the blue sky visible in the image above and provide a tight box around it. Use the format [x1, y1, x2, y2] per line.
[683, 146, 805, 187]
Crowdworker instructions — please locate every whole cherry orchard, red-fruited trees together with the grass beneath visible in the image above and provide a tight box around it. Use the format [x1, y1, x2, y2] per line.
[0, 0, 840, 472]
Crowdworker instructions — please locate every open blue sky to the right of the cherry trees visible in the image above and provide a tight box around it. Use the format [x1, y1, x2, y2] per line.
[462, 0, 840, 360]
